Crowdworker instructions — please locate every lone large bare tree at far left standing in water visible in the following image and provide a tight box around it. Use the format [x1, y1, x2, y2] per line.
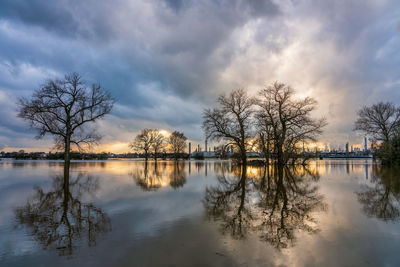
[18, 73, 114, 172]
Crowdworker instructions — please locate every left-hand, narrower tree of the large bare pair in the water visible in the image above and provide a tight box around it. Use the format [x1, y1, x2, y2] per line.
[203, 89, 255, 164]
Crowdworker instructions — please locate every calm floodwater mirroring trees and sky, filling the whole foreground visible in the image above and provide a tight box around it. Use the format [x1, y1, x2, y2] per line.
[0, 160, 400, 266]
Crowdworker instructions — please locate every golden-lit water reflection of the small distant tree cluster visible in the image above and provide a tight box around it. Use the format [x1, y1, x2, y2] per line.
[130, 161, 186, 191]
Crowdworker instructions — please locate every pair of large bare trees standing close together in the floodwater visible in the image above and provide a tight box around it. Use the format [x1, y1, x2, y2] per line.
[203, 82, 327, 164]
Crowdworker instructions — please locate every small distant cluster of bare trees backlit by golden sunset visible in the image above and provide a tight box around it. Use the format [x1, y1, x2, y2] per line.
[129, 129, 187, 160]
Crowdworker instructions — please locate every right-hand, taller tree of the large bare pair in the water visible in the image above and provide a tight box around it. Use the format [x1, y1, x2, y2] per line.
[258, 82, 326, 164]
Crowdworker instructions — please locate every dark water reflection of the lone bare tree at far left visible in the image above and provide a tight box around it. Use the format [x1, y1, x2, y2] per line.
[15, 171, 111, 255]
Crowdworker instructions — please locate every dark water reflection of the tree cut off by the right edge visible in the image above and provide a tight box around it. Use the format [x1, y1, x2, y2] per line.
[357, 168, 400, 222]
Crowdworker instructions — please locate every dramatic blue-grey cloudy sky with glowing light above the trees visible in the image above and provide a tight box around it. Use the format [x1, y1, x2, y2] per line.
[0, 0, 400, 152]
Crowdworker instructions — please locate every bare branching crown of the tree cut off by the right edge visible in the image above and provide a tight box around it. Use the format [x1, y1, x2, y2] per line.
[354, 102, 400, 143]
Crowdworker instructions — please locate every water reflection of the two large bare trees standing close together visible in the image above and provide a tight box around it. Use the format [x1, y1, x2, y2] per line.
[203, 166, 326, 249]
